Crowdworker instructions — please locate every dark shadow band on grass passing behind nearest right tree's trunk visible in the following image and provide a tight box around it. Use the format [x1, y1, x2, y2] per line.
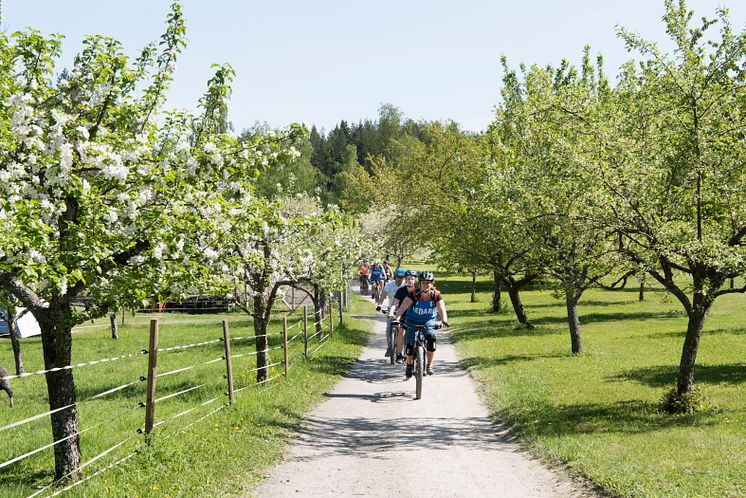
[609, 363, 746, 387]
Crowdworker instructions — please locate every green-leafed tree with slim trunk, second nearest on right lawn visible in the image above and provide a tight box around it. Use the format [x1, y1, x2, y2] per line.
[502, 47, 619, 354]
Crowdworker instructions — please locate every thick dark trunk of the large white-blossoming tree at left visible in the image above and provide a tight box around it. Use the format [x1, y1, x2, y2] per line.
[37, 305, 80, 480]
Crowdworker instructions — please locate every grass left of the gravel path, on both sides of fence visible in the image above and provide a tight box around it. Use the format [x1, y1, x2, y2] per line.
[0, 299, 370, 497]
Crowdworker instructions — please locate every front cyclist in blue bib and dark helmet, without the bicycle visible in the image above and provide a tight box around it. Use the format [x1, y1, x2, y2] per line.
[396, 271, 448, 379]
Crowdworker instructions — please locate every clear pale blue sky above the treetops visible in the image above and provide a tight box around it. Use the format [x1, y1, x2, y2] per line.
[2, 0, 746, 131]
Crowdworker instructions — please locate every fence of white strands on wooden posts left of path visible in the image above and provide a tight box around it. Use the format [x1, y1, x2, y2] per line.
[0, 288, 344, 498]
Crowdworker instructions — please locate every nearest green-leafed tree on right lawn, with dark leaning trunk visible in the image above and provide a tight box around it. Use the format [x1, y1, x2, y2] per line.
[593, 0, 746, 410]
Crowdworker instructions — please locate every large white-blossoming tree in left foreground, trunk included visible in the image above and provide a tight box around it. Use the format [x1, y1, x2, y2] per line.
[0, 4, 268, 479]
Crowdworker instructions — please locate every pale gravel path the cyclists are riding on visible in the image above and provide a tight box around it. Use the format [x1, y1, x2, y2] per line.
[254, 290, 588, 498]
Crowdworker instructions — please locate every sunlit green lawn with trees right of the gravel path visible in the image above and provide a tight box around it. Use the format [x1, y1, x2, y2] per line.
[438, 275, 746, 497]
